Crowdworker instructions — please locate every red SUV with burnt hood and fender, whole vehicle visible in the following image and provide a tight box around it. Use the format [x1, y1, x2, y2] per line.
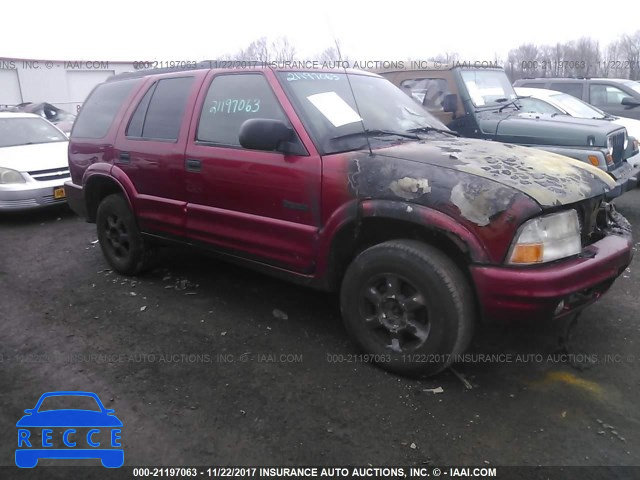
[65, 64, 632, 375]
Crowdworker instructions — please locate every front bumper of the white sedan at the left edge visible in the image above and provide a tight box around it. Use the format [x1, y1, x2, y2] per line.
[0, 178, 67, 212]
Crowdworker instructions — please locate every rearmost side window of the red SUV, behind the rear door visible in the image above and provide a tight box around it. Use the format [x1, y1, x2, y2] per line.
[71, 79, 140, 138]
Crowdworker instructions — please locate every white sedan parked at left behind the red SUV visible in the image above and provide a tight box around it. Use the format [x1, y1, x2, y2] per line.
[0, 112, 70, 212]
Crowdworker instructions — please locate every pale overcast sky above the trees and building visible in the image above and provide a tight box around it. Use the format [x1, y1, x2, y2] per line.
[0, 0, 640, 61]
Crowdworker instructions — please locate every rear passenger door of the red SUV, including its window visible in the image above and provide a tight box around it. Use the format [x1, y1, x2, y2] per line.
[114, 75, 200, 236]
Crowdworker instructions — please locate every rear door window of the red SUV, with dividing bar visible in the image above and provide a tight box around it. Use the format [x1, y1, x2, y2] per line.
[126, 77, 193, 141]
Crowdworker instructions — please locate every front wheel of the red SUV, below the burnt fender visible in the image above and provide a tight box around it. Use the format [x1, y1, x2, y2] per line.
[340, 240, 475, 376]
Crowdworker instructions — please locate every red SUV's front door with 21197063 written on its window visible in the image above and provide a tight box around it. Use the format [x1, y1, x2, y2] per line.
[185, 71, 321, 273]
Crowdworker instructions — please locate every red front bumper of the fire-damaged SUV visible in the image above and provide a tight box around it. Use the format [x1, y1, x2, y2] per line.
[471, 222, 633, 321]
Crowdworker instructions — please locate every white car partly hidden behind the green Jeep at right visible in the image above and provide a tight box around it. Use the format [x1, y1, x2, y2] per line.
[515, 87, 640, 167]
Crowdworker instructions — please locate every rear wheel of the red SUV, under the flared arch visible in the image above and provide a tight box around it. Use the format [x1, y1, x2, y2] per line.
[96, 193, 149, 275]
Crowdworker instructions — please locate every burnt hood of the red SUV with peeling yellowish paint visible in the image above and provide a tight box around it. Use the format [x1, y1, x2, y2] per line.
[374, 136, 615, 207]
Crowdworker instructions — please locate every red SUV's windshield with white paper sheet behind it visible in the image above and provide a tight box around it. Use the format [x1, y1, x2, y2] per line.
[278, 72, 448, 153]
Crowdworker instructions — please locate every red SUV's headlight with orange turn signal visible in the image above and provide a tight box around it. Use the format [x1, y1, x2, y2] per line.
[508, 210, 582, 265]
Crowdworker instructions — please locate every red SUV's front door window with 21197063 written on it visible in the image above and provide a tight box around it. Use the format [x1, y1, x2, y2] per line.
[197, 74, 288, 146]
